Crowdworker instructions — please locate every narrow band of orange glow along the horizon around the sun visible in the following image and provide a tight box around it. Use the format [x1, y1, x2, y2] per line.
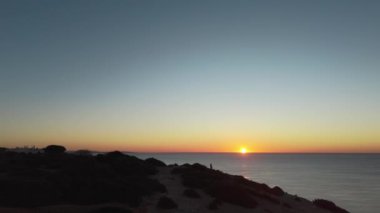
[0, 137, 380, 154]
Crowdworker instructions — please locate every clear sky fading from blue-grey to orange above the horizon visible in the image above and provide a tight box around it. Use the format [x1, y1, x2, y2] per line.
[0, 0, 380, 152]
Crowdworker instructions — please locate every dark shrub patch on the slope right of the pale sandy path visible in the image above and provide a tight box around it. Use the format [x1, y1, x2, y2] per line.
[173, 164, 284, 209]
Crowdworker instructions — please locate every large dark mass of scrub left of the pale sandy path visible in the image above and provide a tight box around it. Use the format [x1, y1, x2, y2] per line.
[0, 146, 166, 207]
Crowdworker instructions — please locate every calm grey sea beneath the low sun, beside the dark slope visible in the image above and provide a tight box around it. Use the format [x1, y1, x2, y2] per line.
[135, 153, 380, 213]
